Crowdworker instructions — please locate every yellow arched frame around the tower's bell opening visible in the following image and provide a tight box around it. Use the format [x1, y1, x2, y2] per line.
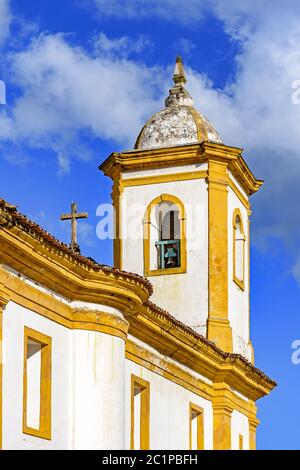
[143, 194, 187, 276]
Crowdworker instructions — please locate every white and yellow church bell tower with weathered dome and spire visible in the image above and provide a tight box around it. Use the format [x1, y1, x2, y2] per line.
[100, 57, 262, 362]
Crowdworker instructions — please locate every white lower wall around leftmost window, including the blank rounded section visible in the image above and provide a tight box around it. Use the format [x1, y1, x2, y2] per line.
[3, 302, 125, 450]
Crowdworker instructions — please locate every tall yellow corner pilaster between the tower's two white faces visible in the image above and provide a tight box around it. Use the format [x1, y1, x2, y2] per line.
[207, 158, 232, 352]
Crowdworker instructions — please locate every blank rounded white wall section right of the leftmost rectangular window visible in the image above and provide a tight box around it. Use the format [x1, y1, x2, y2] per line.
[73, 330, 125, 449]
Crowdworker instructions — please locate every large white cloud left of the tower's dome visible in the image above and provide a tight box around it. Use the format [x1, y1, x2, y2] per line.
[0, 35, 166, 171]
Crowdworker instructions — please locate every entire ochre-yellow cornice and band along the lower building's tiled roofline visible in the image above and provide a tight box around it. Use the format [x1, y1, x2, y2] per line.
[0, 201, 275, 399]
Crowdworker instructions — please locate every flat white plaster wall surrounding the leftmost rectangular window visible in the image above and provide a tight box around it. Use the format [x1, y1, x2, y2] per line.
[3, 302, 71, 450]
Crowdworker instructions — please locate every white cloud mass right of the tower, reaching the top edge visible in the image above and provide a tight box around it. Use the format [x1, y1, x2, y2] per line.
[87, 0, 300, 282]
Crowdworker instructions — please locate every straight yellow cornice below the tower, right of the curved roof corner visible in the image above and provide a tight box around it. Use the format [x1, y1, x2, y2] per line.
[129, 304, 276, 400]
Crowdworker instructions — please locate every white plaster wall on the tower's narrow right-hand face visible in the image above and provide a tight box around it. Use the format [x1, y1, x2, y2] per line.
[228, 188, 251, 360]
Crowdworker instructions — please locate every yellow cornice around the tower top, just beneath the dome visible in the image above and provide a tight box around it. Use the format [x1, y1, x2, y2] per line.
[99, 142, 263, 196]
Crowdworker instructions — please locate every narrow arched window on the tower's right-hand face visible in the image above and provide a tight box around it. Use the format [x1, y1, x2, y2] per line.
[233, 213, 245, 287]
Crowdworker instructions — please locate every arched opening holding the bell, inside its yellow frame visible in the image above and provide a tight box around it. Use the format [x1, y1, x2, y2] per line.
[155, 201, 180, 269]
